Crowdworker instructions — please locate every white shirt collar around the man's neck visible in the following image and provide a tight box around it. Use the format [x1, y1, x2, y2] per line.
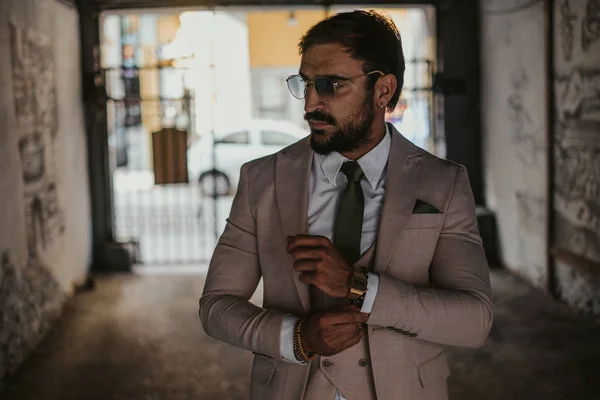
[315, 124, 392, 190]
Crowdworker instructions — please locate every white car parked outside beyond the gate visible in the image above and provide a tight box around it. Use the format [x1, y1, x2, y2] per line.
[188, 119, 309, 196]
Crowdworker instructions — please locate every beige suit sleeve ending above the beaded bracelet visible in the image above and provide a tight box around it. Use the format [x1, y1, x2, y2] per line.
[199, 165, 285, 359]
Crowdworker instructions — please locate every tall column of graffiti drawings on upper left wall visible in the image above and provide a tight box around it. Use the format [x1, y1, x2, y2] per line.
[10, 24, 65, 261]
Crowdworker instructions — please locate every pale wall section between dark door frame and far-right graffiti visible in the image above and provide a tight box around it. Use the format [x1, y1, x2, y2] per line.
[481, 0, 548, 288]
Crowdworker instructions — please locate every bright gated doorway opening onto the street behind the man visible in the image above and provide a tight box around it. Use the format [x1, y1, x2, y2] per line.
[101, 6, 436, 267]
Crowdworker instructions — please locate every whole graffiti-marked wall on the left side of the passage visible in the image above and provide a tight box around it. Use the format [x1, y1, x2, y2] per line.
[0, 0, 91, 380]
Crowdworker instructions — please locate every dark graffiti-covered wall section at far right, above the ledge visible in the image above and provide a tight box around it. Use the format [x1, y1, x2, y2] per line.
[554, 0, 600, 262]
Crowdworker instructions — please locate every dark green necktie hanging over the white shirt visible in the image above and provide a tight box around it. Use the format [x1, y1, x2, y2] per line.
[333, 161, 365, 266]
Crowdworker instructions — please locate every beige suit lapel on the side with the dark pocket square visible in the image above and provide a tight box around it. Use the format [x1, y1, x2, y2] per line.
[374, 126, 425, 273]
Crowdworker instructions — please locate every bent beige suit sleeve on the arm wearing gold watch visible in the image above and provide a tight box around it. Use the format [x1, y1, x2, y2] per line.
[368, 166, 492, 347]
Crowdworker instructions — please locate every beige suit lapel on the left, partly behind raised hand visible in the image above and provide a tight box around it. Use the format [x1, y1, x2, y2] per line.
[275, 139, 313, 312]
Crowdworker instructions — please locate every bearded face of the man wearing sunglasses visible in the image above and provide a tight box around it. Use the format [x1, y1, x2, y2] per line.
[300, 44, 375, 154]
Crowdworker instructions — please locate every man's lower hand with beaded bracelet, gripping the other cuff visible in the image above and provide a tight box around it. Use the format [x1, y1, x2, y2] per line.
[301, 305, 369, 356]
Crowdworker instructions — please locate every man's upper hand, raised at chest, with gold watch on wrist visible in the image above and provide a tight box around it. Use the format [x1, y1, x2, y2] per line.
[287, 235, 352, 298]
